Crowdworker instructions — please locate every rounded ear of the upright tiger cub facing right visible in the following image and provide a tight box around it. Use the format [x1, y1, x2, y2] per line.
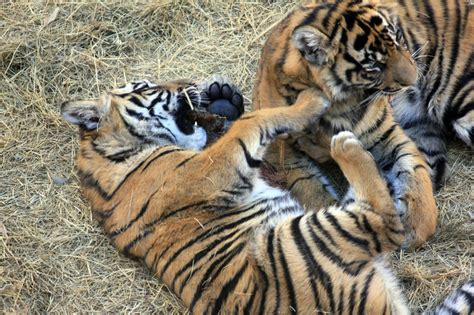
[292, 25, 337, 66]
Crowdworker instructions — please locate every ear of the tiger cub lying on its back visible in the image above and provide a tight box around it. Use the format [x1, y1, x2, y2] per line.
[61, 98, 107, 130]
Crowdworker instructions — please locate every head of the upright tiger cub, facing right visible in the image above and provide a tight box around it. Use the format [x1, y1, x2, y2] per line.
[292, 0, 417, 100]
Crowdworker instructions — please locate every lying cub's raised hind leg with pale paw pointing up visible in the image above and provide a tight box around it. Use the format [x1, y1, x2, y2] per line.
[331, 131, 405, 254]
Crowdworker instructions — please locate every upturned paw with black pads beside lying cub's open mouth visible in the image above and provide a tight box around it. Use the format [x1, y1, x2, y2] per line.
[201, 76, 244, 121]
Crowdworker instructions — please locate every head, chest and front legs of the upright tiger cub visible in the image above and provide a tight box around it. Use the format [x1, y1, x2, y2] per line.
[253, 0, 444, 246]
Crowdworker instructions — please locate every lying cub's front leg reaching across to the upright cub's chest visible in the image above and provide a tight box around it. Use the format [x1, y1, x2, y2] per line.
[202, 89, 329, 202]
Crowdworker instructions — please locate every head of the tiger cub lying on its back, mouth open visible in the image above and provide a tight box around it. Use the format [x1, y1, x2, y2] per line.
[61, 80, 207, 150]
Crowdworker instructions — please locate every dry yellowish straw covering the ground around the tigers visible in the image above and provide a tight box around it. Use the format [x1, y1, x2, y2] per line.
[0, 0, 474, 314]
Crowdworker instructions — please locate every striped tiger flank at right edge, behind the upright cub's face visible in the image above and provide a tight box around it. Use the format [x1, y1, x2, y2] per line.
[384, 0, 474, 188]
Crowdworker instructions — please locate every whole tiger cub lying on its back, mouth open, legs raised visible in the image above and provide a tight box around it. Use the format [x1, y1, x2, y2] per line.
[62, 81, 473, 314]
